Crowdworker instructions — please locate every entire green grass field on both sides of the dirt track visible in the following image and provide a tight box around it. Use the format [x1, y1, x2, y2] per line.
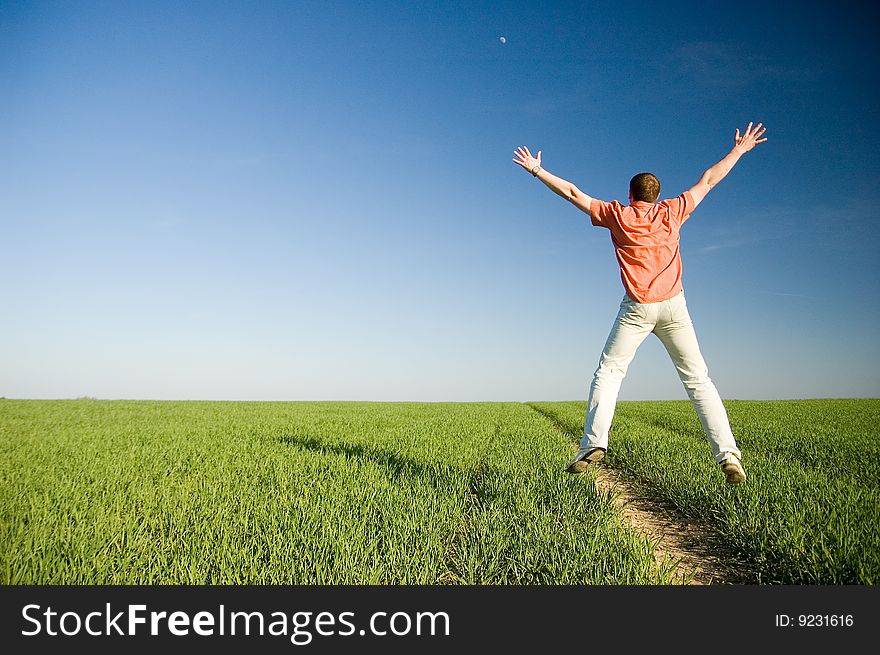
[0, 400, 880, 585]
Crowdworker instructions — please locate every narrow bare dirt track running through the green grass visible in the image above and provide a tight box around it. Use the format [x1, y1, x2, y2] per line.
[526, 403, 755, 585]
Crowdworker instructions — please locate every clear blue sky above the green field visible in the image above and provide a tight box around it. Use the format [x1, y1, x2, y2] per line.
[0, 1, 880, 400]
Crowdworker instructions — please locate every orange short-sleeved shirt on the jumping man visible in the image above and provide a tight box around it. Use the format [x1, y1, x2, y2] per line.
[590, 191, 694, 303]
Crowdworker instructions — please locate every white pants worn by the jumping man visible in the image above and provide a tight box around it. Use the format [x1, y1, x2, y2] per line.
[580, 292, 742, 463]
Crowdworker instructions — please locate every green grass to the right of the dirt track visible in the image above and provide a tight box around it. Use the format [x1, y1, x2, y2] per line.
[534, 399, 880, 584]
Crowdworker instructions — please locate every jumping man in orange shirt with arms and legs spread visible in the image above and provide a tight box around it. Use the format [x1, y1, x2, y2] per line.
[513, 123, 767, 484]
